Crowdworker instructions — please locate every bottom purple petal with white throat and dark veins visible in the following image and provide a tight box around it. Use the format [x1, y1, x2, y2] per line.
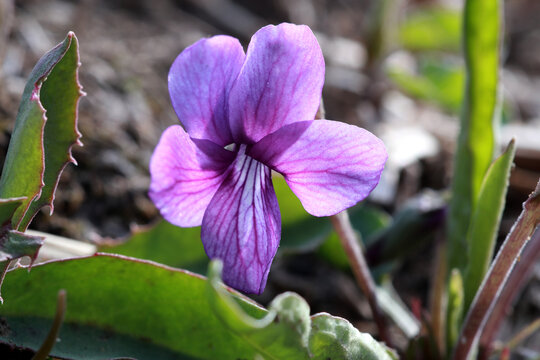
[201, 146, 281, 294]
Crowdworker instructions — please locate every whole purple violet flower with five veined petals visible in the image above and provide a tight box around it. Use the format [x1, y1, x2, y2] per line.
[150, 24, 387, 294]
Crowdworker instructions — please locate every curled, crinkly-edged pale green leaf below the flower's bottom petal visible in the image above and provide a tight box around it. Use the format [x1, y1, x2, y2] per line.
[208, 262, 395, 360]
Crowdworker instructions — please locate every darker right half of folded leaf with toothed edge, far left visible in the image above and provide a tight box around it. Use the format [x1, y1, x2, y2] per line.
[19, 32, 83, 229]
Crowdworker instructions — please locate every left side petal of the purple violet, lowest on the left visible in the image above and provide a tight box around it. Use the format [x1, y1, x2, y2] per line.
[149, 125, 234, 227]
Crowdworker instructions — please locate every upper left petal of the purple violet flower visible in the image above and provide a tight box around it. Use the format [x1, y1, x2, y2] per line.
[169, 35, 245, 146]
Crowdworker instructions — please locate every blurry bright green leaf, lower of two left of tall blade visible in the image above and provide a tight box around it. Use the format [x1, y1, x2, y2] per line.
[387, 56, 465, 114]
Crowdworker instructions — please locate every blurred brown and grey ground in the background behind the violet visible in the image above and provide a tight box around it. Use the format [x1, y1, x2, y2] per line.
[0, 0, 540, 351]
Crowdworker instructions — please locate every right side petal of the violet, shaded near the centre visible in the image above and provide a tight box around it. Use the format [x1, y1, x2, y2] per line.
[248, 120, 387, 216]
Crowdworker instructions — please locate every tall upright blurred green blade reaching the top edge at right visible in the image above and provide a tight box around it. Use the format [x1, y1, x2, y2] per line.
[448, 0, 502, 271]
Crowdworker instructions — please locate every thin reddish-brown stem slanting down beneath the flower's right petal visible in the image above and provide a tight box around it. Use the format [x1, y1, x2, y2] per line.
[330, 210, 392, 346]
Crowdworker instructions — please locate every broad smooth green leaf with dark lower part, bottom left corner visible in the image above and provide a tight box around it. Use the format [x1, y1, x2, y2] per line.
[0, 254, 266, 360]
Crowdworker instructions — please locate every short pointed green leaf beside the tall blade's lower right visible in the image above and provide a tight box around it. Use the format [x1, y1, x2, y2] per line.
[464, 140, 515, 311]
